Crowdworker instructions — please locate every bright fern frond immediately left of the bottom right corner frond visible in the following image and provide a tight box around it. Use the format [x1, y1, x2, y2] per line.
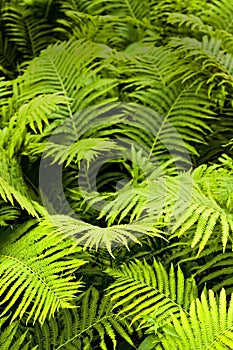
[107, 260, 197, 325]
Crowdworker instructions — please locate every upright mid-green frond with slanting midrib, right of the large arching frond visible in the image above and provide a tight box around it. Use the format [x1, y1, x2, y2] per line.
[125, 84, 214, 157]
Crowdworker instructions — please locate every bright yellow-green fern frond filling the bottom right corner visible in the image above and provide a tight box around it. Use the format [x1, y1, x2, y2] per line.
[161, 289, 233, 350]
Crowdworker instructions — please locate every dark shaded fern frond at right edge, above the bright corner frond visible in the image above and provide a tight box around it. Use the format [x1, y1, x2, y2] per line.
[157, 235, 233, 295]
